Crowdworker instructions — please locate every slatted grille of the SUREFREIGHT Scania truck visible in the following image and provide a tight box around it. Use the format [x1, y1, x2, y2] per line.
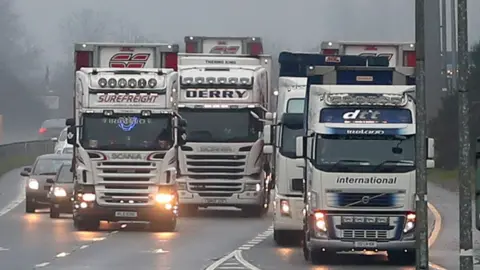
[96, 161, 158, 206]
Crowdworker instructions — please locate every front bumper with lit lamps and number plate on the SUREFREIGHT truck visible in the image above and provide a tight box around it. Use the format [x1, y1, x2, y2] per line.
[73, 202, 177, 222]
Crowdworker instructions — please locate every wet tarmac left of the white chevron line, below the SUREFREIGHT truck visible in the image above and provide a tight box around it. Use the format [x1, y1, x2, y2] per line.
[0, 170, 271, 270]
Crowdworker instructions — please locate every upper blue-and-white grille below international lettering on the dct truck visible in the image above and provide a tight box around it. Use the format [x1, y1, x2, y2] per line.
[327, 193, 405, 208]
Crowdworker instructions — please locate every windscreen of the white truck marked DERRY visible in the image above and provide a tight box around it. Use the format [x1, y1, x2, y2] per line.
[179, 108, 262, 142]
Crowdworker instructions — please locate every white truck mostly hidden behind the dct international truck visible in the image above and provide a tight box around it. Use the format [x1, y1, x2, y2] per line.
[263, 52, 318, 245]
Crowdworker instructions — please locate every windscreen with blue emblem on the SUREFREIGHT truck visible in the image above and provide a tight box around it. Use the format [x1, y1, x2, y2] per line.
[80, 114, 173, 151]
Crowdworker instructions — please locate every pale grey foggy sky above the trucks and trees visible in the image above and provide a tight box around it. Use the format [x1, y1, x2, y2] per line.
[10, 0, 480, 64]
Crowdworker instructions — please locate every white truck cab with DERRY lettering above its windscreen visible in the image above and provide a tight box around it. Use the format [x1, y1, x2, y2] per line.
[177, 45, 272, 216]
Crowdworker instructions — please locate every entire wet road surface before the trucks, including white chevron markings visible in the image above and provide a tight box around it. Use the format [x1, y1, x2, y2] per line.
[0, 170, 442, 270]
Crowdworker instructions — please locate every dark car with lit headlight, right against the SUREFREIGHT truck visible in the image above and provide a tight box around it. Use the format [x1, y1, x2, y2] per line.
[47, 164, 73, 218]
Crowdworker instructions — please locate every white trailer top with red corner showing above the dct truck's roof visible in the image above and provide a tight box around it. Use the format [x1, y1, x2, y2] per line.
[320, 41, 416, 67]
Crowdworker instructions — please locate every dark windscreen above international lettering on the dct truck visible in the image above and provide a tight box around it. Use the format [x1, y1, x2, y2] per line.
[314, 135, 415, 172]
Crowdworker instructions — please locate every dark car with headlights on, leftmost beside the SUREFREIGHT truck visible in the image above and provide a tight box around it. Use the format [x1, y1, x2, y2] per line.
[20, 154, 72, 213]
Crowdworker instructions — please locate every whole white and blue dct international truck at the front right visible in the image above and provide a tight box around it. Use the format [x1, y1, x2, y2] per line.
[296, 55, 434, 264]
